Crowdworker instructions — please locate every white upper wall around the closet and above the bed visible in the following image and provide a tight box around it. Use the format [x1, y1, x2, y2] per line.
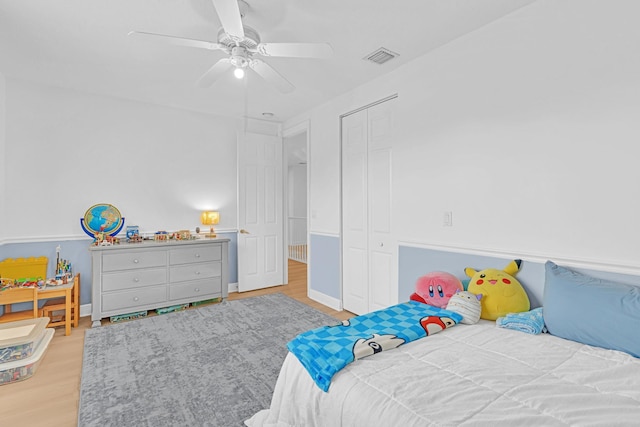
[284, 0, 640, 267]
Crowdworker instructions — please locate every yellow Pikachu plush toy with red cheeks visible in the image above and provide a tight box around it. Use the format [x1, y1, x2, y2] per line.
[464, 259, 531, 320]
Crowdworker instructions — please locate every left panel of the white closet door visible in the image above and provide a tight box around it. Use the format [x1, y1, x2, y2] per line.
[342, 110, 369, 314]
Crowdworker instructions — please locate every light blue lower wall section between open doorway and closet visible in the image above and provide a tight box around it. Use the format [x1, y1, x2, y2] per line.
[309, 233, 342, 300]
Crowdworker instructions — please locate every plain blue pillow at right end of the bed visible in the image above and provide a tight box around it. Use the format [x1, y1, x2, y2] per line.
[543, 261, 640, 357]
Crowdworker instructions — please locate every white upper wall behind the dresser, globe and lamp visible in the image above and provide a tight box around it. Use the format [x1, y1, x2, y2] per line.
[0, 79, 241, 241]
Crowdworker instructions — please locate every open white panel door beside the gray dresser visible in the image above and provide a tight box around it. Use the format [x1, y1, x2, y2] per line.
[238, 133, 284, 292]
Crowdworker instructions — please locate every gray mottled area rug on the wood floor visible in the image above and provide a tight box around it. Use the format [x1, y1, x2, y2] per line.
[78, 294, 337, 427]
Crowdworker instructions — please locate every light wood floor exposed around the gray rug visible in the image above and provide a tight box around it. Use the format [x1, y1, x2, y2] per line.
[0, 261, 354, 427]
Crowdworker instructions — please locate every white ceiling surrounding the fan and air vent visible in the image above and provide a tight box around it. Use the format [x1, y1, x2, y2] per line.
[0, 0, 535, 121]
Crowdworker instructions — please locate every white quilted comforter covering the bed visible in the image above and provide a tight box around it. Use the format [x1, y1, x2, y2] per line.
[245, 321, 640, 427]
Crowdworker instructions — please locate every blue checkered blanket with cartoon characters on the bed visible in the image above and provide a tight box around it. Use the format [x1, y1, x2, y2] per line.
[287, 301, 462, 391]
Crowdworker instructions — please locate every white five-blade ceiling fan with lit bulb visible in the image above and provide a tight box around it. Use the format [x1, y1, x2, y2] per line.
[129, 0, 333, 93]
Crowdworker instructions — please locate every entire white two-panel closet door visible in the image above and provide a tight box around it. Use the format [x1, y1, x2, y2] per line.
[342, 99, 398, 314]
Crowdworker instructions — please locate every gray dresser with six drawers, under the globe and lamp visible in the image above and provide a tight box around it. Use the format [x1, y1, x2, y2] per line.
[90, 239, 229, 326]
